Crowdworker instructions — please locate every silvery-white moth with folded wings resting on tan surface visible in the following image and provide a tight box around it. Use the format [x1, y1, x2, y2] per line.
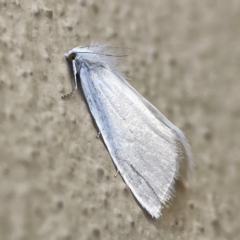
[62, 45, 192, 218]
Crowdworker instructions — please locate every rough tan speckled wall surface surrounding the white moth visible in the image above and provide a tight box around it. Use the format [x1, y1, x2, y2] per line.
[0, 0, 240, 240]
